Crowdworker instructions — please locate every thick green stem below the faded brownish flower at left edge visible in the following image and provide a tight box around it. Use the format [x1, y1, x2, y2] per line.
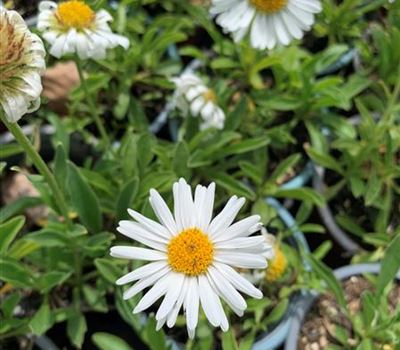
[0, 111, 72, 227]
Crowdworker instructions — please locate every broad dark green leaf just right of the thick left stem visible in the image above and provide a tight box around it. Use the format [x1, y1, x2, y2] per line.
[68, 162, 102, 232]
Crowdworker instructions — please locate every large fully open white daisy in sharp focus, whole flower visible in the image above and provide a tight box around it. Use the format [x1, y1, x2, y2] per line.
[111, 179, 267, 338]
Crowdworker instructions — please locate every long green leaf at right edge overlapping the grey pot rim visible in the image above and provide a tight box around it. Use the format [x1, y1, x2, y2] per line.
[376, 235, 400, 301]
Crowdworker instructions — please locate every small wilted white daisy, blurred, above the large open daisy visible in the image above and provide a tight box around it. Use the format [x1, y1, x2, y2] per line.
[171, 73, 225, 130]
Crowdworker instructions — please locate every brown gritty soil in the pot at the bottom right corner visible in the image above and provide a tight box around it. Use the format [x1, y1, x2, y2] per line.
[297, 276, 400, 350]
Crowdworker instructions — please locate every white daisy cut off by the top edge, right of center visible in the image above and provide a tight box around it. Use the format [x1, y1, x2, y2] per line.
[210, 0, 321, 50]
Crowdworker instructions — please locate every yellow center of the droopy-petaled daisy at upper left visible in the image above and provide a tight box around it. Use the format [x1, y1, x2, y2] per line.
[56, 0, 95, 29]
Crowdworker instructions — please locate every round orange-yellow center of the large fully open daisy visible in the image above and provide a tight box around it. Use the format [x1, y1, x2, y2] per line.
[167, 228, 214, 276]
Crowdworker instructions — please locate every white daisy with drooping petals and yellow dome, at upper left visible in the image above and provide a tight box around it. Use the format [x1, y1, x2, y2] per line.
[37, 0, 129, 59]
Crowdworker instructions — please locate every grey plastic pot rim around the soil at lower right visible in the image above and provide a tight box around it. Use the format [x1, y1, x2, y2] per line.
[285, 263, 400, 350]
